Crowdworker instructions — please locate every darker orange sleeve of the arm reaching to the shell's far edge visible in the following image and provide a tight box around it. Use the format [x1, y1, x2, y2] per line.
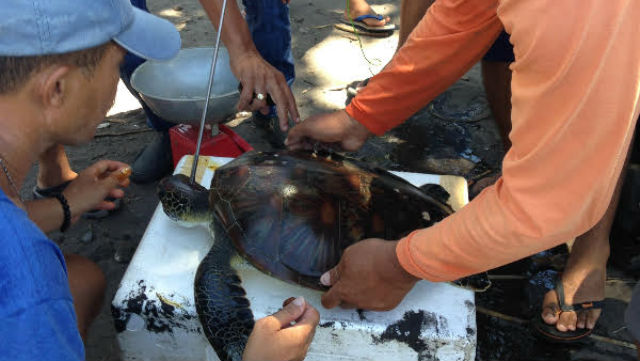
[346, 0, 502, 135]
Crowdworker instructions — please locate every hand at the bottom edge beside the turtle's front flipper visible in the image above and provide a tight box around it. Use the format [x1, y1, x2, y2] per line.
[242, 297, 320, 360]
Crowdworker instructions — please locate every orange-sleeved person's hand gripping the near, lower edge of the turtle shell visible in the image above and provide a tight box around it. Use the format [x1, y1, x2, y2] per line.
[320, 238, 418, 311]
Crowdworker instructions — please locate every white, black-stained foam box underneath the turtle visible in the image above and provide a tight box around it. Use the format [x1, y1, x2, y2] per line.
[112, 157, 476, 360]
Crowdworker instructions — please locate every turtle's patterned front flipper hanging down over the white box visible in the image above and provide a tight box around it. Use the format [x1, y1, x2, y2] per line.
[194, 220, 254, 361]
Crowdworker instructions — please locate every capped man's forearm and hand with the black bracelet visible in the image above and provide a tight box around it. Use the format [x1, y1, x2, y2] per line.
[25, 160, 130, 233]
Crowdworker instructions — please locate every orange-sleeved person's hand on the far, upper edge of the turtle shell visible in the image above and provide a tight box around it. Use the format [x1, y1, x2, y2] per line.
[284, 110, 371, 151]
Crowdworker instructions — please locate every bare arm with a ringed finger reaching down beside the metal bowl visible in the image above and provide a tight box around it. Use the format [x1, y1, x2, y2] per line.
[200, 0, 300, 131]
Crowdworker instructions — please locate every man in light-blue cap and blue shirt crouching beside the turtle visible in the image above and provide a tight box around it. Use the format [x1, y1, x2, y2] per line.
[0, 0, 319, 360]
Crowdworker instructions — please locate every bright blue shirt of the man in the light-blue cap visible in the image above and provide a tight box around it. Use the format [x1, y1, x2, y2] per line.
[0, 190, 84, 361]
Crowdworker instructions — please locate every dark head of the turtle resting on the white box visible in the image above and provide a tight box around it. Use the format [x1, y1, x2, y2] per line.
[158, 174, 212, 225]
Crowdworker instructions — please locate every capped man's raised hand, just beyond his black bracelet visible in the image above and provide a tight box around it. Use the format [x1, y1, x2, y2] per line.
[62, 160, 131, 220]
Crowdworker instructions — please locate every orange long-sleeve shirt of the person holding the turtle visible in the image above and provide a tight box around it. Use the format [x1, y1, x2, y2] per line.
[347, 0, 640, 281]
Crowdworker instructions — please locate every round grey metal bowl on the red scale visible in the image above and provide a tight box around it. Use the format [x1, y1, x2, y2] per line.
[131, 47, 240, 124]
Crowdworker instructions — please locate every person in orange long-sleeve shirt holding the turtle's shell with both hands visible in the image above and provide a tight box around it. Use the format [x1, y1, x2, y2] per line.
[287, 0, 640, 344]
